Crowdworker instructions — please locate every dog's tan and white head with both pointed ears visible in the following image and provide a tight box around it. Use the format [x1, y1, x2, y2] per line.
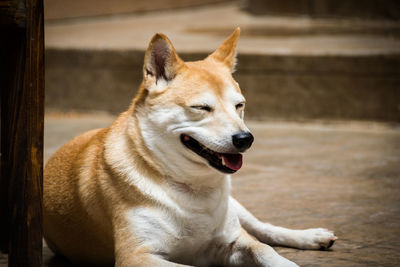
[135, 28, 253, 178]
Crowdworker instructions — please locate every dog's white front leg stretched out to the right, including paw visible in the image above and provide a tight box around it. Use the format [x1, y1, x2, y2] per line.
[230, 197, 337, 249]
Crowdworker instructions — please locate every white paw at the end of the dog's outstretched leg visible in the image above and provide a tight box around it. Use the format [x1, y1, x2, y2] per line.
[296, 228, 338, 249]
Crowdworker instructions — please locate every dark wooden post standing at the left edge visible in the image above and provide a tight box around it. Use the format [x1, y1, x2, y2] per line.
[0, 0, 44, 267]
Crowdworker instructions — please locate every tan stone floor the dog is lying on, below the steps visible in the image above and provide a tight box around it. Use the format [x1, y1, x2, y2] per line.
[36, 115, 400, 266]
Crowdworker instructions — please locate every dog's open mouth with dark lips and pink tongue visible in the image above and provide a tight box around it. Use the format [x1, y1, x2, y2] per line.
[181, 134, 243, 173]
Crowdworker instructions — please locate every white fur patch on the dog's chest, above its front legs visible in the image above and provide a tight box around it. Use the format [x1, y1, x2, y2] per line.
[127, 178, 240, 265]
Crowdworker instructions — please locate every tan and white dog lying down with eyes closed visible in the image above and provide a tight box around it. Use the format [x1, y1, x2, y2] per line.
[44, 29, 336, 266]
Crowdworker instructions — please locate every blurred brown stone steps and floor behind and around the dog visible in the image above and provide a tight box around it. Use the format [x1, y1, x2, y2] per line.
[7, 0, 400, 267]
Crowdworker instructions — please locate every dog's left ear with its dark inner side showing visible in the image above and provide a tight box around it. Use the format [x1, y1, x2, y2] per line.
[143, 33, 184, 92]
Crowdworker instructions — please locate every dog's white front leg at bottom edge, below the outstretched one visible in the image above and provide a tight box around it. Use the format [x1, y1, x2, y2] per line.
[217, 229, 298, 267]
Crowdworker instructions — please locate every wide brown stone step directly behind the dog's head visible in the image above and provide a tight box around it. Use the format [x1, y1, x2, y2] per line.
[46, 3, 400, 122]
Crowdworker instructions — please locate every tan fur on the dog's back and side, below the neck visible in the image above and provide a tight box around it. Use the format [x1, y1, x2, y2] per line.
[44, 113, 159, 265]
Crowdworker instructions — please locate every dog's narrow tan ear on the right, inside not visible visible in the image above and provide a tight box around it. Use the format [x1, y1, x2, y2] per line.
[208, 27, 240, 72]
